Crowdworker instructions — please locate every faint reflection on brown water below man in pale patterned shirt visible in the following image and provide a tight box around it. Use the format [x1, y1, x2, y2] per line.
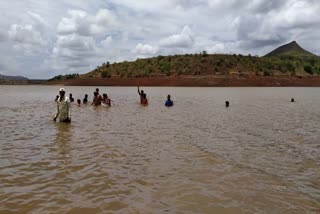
[54, 123, 71, 163]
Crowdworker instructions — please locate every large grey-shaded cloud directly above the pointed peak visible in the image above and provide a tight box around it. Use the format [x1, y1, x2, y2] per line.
[235, 0, 320, 50]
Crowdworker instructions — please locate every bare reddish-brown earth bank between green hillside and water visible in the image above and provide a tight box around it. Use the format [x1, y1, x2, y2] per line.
[47, 75, 320, 87]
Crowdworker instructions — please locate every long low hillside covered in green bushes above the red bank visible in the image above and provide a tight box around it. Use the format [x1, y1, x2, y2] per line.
[87, 51, 320, 78]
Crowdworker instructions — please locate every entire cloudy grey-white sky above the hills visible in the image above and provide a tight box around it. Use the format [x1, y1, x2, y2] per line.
[0, 0, 320, 78]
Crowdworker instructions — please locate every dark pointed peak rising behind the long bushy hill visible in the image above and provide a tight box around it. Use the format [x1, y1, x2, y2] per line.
[266, 41, 316, 57]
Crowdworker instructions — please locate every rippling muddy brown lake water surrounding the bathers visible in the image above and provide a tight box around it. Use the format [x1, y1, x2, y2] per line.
[0, 86, 320, 213]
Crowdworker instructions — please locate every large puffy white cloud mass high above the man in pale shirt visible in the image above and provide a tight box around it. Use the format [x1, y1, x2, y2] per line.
[52, 9, 119, 71]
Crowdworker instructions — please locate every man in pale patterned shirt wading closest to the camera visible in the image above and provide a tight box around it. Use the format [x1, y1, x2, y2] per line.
[53, 88, 71, 123]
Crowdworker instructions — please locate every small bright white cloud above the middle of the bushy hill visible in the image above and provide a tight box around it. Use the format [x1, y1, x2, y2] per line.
[160, 26, 194, 48]
